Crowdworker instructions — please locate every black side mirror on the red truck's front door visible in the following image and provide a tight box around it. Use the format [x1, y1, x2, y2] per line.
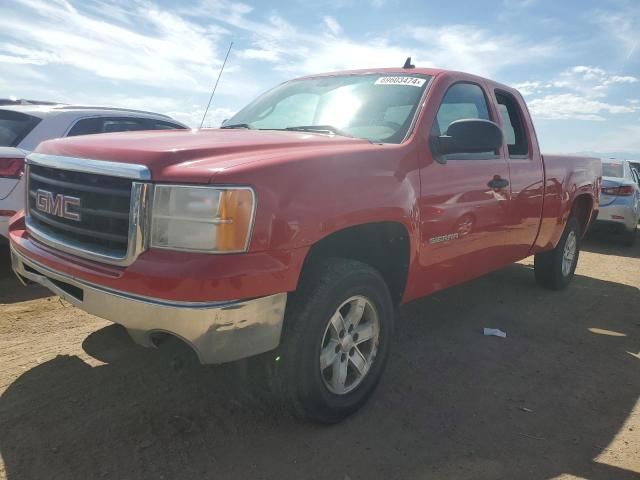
[433, 118, 503, 155]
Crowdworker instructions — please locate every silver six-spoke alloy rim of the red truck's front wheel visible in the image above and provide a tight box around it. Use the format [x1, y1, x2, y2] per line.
[319, 295, 380, 395]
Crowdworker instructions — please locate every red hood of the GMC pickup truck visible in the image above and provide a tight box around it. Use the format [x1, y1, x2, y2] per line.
[36, 129, 370, 183]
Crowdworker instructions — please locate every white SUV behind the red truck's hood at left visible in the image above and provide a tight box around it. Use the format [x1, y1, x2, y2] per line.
[0, 103, 188, 240]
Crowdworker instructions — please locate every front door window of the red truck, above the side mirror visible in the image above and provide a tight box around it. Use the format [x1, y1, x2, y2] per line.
[433, 83, 491, 135]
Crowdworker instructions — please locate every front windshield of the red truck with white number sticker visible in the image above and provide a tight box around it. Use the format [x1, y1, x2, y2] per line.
[223, 74, 431, 143]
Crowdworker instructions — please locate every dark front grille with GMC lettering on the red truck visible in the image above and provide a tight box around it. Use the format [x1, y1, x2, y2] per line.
[28, 165, 133, 258]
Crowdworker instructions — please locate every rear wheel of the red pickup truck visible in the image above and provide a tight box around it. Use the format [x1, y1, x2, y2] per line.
[534, 217, 581, 290]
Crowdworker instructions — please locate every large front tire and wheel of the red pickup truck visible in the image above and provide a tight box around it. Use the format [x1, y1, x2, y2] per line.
[275, 258, 394, 423]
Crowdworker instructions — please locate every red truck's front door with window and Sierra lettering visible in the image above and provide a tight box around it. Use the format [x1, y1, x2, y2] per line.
[420, 82, 509, 294]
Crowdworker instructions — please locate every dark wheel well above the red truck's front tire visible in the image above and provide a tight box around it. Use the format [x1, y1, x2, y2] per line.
[302, 222, 409, 305]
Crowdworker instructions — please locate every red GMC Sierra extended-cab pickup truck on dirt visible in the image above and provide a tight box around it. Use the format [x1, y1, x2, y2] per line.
[10, 68, 601, 422]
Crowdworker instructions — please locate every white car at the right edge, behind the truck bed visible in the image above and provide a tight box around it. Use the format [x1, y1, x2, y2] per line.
[593, 159, 640, 245]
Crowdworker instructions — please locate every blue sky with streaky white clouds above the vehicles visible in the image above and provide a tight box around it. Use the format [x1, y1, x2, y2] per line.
[0, 0, 640, 158]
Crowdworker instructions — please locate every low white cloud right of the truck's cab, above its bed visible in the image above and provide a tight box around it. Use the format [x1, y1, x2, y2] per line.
[529, 93, 640, 120]
